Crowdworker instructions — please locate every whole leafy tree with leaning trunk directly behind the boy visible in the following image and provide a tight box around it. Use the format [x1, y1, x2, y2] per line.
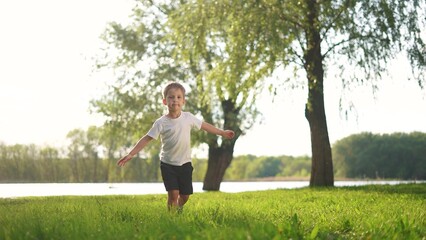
[93, 1, 266, 190]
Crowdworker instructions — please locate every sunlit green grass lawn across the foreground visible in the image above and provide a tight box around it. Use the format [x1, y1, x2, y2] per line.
[0, 184, 426, 240]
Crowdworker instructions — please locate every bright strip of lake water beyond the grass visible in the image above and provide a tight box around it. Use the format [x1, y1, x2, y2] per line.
[0, 181, 420, 198]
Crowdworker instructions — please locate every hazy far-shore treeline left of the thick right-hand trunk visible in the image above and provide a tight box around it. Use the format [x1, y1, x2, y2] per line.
[0, 139, 310, 182]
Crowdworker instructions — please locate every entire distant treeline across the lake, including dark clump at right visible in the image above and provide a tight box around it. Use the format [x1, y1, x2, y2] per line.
[0, 132, 426, 182]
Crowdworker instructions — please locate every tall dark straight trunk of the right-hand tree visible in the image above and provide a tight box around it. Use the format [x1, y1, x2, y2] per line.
[304, 0, 334, 187]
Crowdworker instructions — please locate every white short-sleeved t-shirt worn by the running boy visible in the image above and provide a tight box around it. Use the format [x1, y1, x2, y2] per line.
[147, 112, 202, 166]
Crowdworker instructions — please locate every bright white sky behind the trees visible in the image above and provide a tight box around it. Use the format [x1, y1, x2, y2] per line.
[0, 0, 426, 156]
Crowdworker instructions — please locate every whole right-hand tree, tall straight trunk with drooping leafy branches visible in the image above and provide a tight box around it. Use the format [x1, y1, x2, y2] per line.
[179, 0, 426, 186]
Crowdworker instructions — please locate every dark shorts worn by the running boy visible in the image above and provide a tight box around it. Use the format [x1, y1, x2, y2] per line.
[161, 162, 194, 195]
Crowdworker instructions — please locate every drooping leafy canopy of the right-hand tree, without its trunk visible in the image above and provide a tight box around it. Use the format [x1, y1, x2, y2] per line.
[188, 0, 426, 89]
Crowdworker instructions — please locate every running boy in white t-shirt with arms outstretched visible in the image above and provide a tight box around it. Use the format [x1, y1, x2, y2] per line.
[117, 83, 235, 212]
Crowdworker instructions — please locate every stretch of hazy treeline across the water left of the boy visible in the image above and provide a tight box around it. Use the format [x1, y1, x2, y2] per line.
[0, 127, 161, 183]
